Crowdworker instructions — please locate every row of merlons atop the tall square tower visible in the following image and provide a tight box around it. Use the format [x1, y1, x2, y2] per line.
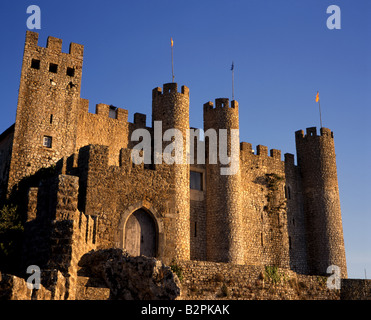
[26, 31, 84, 60]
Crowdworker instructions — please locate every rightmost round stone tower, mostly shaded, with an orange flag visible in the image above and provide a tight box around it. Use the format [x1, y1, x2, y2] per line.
[295, 127, 347, 278]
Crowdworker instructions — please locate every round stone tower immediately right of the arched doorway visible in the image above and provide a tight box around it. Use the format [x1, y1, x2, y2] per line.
[152, 83, 190, 260]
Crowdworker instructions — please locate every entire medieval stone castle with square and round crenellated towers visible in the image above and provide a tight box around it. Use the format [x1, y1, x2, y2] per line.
[0, 31, 347, 288]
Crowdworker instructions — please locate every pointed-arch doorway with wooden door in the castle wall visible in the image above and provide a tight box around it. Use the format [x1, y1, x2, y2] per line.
[124, 209, 157, 257]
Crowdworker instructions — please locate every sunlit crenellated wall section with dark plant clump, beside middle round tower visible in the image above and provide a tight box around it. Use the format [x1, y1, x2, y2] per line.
[241, 143, 290, 267]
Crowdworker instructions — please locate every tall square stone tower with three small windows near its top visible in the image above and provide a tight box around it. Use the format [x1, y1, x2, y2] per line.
[8, 31, 84, 191]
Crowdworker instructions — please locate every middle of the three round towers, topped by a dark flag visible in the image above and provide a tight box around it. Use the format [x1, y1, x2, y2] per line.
[204, 98, 243, 264]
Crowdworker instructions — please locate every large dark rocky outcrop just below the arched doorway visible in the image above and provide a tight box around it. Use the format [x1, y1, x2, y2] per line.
[78, 248, 180, 300]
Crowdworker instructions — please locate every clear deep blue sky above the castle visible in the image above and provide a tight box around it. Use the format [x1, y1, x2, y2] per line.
[0, 0, 371, 278]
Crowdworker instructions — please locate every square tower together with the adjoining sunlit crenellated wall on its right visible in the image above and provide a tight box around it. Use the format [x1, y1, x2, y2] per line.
[6, 31, 129, 191]
